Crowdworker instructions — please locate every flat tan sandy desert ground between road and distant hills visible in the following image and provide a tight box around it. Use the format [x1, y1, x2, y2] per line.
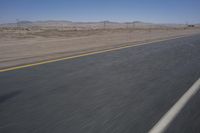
[0, 28, 200, 69]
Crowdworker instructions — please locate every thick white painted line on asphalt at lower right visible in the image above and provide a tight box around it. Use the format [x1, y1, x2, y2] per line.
[148, 78, 200, 133]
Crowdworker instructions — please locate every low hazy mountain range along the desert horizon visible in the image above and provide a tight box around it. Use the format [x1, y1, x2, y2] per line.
[0, 20, 190, 28]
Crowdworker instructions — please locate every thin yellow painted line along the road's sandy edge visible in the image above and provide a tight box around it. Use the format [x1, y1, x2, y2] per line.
[0, 36, 190, 73]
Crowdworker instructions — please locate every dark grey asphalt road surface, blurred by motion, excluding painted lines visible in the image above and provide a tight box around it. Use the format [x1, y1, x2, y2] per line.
[0, 35, 200, 133]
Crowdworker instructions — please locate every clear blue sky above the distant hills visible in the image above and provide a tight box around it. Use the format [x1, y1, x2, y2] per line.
[0, 0, 200, 23]
